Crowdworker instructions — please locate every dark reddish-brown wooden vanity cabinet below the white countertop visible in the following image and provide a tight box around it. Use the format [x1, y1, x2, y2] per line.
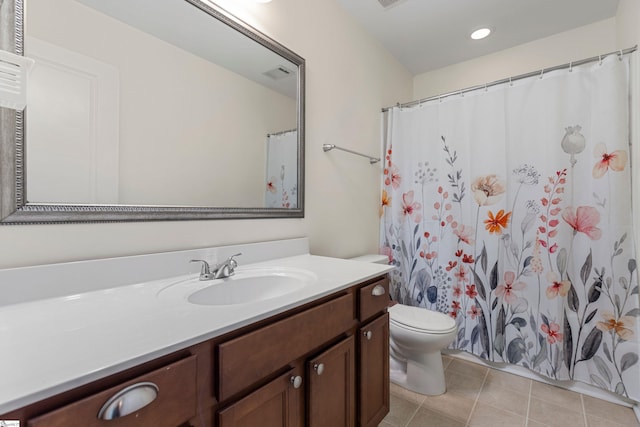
[0, 276, 389, 427]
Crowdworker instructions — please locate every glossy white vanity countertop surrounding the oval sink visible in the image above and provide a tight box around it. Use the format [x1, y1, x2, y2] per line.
[0, 244, 391, 414]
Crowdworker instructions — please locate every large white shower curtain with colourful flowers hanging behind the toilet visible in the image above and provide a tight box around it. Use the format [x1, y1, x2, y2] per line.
[380, 54, 640, 401]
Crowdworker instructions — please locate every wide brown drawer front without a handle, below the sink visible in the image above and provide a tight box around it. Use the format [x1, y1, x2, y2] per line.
[217, 293, 356, 402]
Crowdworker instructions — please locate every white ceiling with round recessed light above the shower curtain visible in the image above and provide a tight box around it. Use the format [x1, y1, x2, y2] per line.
[336, 0, 618, 75]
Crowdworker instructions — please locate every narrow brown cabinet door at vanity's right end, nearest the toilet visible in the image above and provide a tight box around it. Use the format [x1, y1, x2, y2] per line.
[358, 313, 389, 426]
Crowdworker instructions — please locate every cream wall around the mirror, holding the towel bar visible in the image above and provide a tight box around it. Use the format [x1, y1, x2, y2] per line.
[0, 0, 412, 268]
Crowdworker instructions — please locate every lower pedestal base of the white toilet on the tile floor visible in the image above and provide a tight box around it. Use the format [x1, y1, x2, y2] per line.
[389, 351, 447, 396]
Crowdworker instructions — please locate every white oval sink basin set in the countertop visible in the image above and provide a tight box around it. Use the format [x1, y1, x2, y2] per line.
[160, 268, 317, 306]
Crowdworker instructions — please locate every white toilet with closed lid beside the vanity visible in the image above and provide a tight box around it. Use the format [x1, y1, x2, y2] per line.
[352, 255, 457, 396]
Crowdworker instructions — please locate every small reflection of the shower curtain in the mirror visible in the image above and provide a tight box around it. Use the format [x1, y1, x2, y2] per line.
[265, 129, 298, 208]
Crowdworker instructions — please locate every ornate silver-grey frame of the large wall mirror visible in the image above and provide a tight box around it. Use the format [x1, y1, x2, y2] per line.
[0, 0, 305, 224]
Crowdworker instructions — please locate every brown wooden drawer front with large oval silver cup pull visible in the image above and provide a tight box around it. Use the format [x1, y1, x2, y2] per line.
[27, 356, 196, 427]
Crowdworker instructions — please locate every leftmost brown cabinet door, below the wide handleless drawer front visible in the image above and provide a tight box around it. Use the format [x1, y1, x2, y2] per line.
[218, 369, 304, 427]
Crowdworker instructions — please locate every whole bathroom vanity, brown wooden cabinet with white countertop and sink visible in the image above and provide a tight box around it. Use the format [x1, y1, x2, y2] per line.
[0, 239, 389, 427]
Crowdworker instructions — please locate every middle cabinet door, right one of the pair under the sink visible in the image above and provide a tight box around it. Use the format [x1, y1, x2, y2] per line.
[307, 336, 355, 427]
